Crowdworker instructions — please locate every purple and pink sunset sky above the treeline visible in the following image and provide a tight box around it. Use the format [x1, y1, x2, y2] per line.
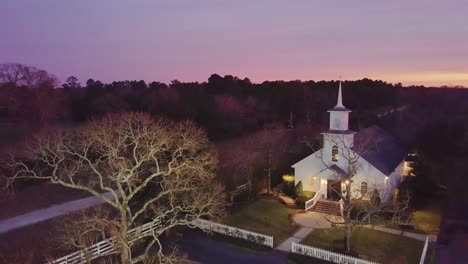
[0, 0, 468, 86]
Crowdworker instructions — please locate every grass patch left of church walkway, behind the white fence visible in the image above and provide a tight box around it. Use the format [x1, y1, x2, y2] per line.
[223, 198, 297, 246]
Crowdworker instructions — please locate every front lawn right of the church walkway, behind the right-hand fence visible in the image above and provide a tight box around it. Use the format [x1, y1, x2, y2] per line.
[301, 227, 432, 263]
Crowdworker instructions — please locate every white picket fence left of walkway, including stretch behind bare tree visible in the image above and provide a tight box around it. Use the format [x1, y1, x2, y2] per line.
[48, 219, 273, 264]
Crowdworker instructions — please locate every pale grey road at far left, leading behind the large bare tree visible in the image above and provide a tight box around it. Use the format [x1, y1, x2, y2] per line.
[0, 193, 117, 234]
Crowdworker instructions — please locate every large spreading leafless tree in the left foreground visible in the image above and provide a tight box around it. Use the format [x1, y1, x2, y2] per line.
[2, 113, 226, 264]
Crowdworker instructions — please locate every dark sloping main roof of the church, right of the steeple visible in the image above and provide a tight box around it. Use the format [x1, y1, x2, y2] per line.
[352, 126, 407, 175]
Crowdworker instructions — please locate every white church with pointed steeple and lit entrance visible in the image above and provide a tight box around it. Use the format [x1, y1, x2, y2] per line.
[292, 82, 409, 204]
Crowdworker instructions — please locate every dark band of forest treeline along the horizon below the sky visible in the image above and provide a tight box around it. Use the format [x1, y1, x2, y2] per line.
[0, 64, 466, 142]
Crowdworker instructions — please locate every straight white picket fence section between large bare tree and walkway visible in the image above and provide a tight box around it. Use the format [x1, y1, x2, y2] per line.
[195, 219, 273, 248]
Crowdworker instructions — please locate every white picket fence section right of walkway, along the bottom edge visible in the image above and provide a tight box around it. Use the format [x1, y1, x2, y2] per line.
[291, 241, 379, 264]
